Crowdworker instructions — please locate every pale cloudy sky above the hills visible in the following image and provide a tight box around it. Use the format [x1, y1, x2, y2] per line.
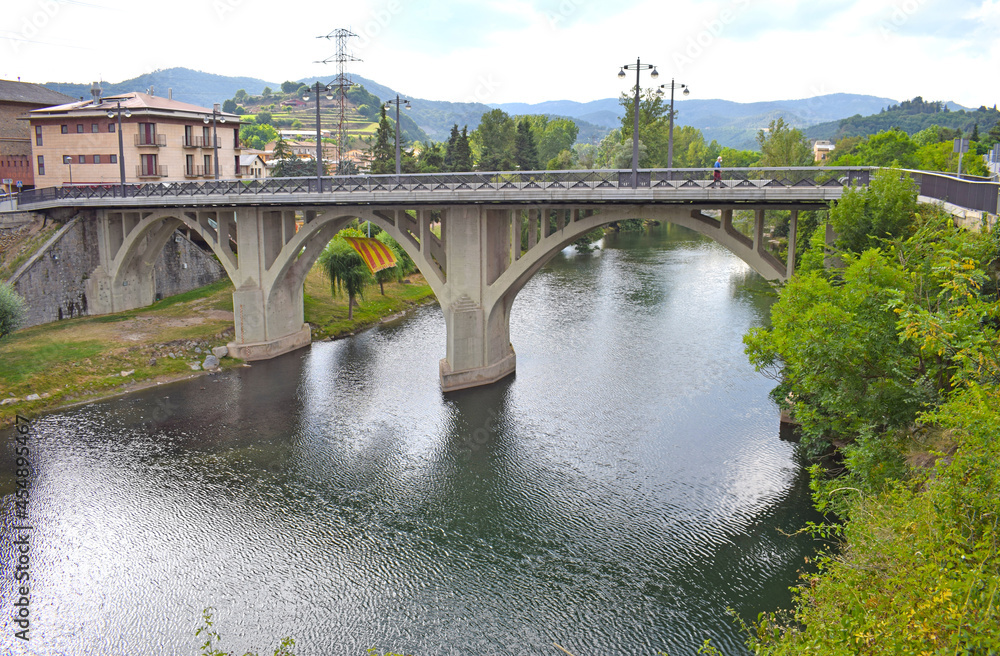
[0, 0, 1000, 107]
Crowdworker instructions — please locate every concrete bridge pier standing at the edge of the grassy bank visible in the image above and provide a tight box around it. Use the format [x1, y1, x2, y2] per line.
[228, 207, 312, 360]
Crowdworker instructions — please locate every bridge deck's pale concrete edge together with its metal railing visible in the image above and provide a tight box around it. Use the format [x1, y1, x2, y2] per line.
[11, 166, 872, 209]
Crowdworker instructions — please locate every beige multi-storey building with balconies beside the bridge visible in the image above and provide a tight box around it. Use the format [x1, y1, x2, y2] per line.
[29, 92, 243, 187]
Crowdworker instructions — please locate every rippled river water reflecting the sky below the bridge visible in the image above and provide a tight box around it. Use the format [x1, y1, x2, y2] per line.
[0, 227, 813, 656]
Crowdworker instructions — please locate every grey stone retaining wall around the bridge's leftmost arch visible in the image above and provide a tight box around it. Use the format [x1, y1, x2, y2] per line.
[13, 218, 226, 327]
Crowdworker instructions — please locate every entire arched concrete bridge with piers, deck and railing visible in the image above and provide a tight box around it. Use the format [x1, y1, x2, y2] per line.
[7, 167, 872, 391]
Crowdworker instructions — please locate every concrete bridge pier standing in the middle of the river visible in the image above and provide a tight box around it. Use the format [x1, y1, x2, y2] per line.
[438, 205, 520, 392]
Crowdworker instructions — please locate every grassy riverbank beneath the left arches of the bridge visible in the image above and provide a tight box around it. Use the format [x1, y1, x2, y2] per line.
[0, 268, 434, 426]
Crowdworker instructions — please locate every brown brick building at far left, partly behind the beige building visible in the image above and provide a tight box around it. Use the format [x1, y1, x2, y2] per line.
[0, 80, 73, 193]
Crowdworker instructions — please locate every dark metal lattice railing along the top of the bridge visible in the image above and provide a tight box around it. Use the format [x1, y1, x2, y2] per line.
[20, 166, 873, 205]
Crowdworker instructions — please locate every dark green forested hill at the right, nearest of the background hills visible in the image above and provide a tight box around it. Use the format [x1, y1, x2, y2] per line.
[805, 96, 1000, 141]
